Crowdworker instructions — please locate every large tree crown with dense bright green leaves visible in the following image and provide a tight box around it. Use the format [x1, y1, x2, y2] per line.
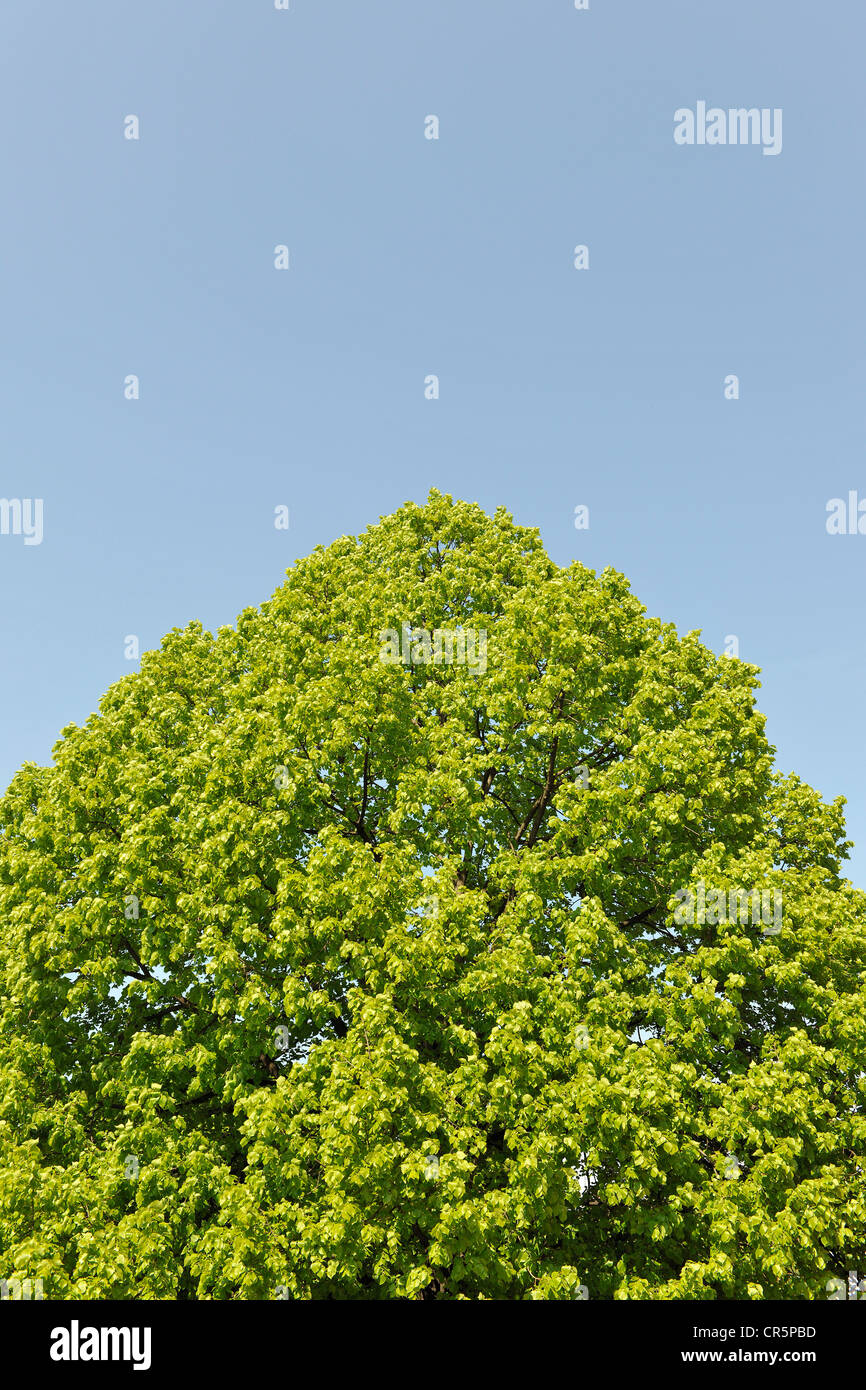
[0, 492, 866, 1300]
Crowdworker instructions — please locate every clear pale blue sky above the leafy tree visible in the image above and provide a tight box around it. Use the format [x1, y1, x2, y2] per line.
[0, 0, 866, 885]
